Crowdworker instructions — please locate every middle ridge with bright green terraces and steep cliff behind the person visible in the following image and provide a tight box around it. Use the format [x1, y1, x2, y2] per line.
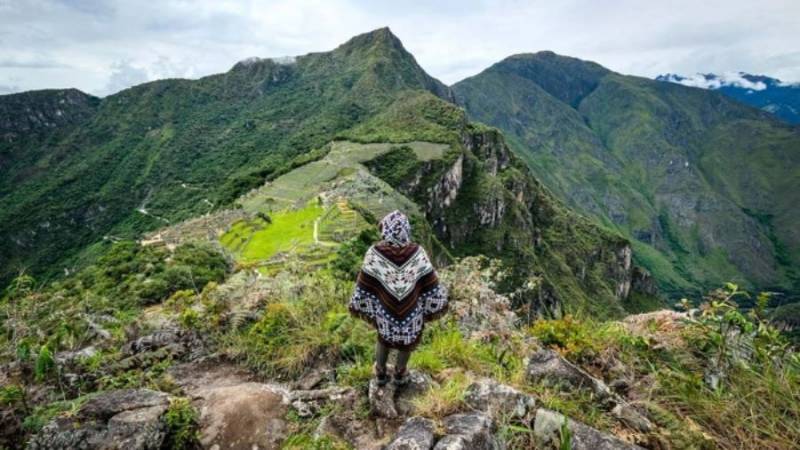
[145, 91, 658, 319]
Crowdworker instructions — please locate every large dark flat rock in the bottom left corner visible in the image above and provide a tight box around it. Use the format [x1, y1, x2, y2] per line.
[28, 389, 169, 450]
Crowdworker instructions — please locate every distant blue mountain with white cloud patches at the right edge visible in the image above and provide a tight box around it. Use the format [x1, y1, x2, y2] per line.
[656, 72, 800, 124]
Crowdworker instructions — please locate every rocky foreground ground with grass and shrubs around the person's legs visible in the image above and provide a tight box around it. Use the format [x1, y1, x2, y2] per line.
[0, 258, 798, 450]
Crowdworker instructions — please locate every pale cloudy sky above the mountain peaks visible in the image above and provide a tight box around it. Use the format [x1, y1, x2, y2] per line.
[0, 0, 800, 96]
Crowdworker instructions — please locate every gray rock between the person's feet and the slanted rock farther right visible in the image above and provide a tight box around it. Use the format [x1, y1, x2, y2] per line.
[464, 378, 536, 419]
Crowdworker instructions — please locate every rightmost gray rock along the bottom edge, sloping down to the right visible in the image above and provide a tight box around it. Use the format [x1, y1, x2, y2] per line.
[533, 409, 643, 450]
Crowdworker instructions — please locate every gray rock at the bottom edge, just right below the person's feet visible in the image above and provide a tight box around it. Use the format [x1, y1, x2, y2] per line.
[434, 412, 496, 450]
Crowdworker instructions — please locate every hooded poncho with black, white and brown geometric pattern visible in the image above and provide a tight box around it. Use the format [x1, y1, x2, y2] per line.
[350, 211, 447, 349]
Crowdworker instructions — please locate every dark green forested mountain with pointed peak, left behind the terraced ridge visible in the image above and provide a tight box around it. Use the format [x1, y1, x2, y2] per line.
[0, 29, 450, 286]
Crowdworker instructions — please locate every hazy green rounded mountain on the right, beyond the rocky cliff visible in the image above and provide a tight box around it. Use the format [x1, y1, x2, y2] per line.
[453, 52, 800, 295]
